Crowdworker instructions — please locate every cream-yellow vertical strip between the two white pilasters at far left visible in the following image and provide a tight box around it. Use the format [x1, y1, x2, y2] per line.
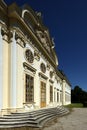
[2, 28, 10, 109]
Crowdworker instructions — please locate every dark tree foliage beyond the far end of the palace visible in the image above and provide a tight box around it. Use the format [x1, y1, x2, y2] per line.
[71, 86, 87, 103]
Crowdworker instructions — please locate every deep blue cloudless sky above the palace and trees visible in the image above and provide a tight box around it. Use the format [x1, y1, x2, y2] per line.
[5, 0, 87, 91]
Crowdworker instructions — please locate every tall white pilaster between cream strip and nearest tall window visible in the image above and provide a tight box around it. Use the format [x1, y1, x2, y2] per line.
[10, 31, 17, 108]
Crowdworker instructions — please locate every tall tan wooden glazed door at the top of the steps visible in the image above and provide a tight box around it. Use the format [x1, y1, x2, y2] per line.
[40, 81, 46, 107]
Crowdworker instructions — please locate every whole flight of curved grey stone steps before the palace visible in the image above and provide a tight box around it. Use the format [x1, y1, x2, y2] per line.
[0, 107, 69, 128]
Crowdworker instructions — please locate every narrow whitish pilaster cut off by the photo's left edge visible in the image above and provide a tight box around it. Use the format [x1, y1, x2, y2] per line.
[0, 26, 3, 109]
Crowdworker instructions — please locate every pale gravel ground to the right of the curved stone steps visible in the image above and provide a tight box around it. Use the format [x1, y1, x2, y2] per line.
[42, 108, 87, 130]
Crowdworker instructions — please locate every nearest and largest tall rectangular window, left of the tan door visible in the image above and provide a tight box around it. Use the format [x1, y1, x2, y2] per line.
[25, 74, 34, 103]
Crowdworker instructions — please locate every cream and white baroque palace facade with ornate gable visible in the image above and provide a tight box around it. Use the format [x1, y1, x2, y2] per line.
[0, 0, 71, 114]
